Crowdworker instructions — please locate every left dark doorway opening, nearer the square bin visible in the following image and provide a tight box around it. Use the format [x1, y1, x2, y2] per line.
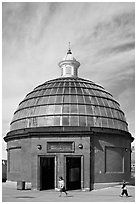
[40, 157, 55, 190]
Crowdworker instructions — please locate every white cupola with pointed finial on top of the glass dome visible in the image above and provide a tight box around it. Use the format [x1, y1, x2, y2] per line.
[58, 42, 80, 77]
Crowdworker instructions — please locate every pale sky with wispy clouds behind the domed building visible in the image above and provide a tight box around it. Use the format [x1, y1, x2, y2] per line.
[2, 2, 135, 159]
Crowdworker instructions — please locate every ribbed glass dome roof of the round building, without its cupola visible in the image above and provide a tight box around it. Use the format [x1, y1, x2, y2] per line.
[10, 77, 128, 131]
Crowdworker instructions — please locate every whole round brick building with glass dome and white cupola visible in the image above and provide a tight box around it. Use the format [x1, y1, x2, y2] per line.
[4, 49, 133, 190]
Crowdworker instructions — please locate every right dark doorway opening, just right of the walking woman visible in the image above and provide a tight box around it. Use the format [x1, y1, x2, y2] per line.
[66, 157, 81, 190]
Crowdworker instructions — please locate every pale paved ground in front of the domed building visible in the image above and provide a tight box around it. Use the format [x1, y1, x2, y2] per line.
[2, 183, 135, 202]
